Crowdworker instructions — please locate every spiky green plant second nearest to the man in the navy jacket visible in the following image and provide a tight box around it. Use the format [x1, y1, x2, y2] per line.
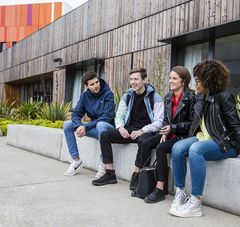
[15, 101, 42, 119]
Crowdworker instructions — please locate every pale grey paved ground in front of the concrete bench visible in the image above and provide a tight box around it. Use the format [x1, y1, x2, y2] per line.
[0, 137, 240, 227]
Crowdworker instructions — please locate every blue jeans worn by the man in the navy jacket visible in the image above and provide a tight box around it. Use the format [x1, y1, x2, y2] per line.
[63, 120, 115, 159]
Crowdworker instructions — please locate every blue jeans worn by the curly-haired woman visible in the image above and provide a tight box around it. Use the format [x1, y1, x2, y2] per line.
[172, 137, 238, 196]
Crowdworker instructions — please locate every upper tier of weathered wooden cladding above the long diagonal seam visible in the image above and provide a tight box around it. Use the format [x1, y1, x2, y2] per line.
[0, 0, 189, 71]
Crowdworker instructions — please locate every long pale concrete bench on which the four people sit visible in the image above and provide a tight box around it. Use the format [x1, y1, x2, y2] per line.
[7, 124, 240, 215]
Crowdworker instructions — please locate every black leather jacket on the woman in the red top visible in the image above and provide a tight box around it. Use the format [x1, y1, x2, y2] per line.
[163, 91, 195, 139]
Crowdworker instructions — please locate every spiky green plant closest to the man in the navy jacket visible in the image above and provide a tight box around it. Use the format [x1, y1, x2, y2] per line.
[38, 102, 72, 122]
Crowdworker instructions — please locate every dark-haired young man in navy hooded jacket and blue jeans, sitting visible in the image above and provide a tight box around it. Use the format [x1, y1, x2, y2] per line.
[64, 72, 115, 178]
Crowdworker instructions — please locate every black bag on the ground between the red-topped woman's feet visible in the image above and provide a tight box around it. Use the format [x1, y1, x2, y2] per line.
[136, 161, 156, 199]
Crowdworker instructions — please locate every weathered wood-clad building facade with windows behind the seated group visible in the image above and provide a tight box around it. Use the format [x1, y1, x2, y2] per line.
[0, 0, 240, 105]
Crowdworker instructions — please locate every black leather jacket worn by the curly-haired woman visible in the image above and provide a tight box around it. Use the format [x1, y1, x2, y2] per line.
[189, 91, 240, 152]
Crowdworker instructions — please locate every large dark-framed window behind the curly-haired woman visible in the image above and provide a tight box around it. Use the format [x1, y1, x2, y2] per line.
[176, 34, 240, 95]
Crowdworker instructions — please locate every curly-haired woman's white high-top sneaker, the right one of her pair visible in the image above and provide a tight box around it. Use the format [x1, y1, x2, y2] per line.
[173, 195, 202, 218]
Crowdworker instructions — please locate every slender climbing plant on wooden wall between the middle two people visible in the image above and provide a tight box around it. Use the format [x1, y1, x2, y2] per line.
[149, 55, 167, 97]
